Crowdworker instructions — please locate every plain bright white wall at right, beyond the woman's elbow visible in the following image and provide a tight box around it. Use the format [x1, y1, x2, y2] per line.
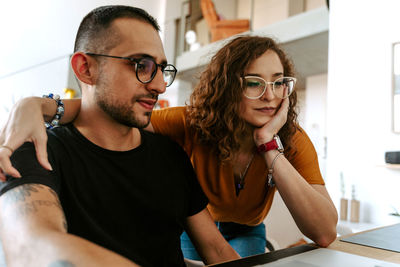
[327, 0, 400, 224]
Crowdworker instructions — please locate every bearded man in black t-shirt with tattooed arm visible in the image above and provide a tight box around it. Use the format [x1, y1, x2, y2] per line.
[0, 6, 238, 266]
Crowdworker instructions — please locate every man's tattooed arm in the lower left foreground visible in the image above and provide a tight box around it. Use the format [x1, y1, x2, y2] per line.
[0, 184, 138, 267]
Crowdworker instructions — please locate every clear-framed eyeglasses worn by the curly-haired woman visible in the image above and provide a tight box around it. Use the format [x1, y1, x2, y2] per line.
[243, 76, 296, 99]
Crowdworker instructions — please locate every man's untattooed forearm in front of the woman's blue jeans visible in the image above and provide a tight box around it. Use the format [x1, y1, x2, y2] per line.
[185, 208, 240, 264]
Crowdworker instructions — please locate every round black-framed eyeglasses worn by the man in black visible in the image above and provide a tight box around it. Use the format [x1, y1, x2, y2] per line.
[85, 53, 177, 87]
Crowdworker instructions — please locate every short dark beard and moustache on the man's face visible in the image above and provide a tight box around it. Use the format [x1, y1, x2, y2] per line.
[95, 74, 157, 129]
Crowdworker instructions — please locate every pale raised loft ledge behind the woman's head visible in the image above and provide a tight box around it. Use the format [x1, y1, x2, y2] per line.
[176, 7, 329, 88]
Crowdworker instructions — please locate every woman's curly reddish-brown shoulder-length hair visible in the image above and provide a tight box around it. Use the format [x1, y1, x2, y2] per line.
[188, 36, 297, 162]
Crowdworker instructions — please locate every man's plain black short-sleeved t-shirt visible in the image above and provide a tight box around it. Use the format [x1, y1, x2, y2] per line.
[0, 124, 208, 266]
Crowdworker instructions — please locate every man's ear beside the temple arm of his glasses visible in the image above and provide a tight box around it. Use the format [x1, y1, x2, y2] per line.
[71, 52, 98, 85]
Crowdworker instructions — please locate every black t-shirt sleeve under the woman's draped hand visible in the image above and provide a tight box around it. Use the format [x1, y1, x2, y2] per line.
[0, 142, 59, 195]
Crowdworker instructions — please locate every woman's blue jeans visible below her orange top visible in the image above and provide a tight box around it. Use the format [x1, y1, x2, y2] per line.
[181, 222, 267, 260]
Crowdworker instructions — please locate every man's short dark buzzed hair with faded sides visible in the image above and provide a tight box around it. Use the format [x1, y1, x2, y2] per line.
[74, 5, 160, 53]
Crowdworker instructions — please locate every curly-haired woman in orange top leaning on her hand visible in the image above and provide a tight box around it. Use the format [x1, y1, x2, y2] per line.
[0, 36, 337, 259]
